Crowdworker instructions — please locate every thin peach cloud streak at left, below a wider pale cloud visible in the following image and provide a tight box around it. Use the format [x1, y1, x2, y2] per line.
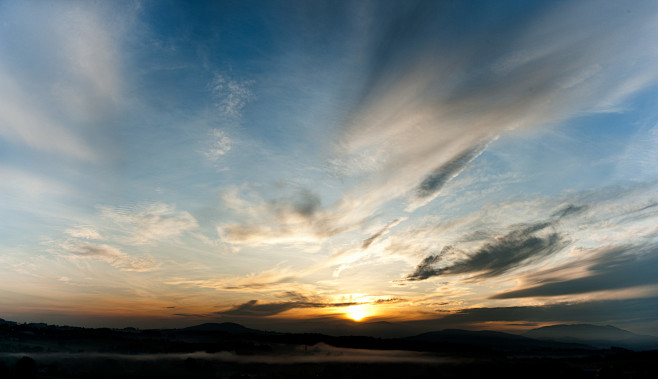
[60, 241, 159, 272]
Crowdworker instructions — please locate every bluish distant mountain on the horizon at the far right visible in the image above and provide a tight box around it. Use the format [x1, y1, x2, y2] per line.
[524, 324, 658, 350]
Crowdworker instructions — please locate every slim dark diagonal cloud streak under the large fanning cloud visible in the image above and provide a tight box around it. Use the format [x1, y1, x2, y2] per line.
[414, 143, 487, 199]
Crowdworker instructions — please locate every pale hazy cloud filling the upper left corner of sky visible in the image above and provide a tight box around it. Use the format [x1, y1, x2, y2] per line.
[0, 2, 132, 161]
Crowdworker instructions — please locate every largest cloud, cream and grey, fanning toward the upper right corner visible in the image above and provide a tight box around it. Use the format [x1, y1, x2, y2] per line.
[332, 2, 658, 224]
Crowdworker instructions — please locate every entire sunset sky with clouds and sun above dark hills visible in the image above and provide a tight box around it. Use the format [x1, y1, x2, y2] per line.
[0, 0, 658, 335]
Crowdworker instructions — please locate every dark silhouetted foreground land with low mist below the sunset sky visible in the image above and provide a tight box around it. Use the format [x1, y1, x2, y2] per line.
[0, 319, 658, 379]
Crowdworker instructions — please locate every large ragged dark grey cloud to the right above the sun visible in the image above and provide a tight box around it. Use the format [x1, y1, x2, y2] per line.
[406, 222, 566, 280]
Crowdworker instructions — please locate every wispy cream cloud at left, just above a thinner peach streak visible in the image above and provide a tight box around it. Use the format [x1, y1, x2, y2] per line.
[100, 203, 199, 245]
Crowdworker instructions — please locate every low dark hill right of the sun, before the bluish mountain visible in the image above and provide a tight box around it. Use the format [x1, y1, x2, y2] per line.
[407, 329, 593, 351]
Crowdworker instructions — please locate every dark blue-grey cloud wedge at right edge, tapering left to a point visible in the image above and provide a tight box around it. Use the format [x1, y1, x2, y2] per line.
[492, 245, 658, 299]
